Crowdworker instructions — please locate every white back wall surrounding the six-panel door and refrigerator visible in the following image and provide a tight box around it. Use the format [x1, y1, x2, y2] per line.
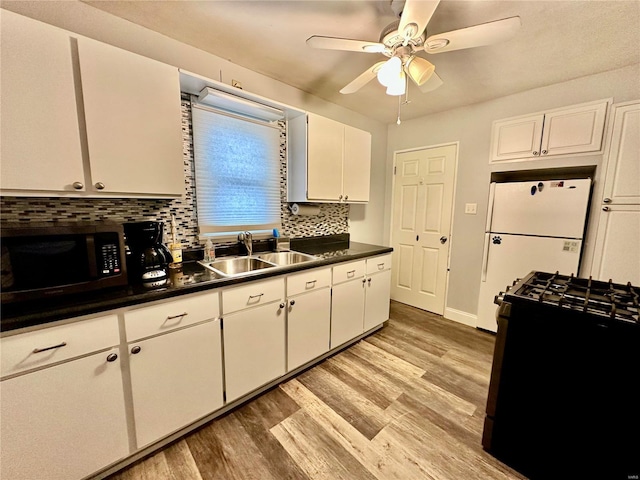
[384, 64, 640, 316]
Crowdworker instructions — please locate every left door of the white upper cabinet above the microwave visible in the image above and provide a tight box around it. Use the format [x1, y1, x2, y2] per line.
[0, 10, 84, 194]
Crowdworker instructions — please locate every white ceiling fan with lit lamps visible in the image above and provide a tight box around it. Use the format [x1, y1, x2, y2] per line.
[307, 0, 520, 95]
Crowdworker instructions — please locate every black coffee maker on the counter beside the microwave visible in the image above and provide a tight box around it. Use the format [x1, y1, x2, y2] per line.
[123, 222, 173, 287]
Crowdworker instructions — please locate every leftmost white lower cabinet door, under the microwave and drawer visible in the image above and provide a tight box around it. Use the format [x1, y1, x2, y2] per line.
[0, 349, 129, 480]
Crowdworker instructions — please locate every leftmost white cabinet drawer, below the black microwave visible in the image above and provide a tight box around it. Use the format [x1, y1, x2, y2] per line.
[0, 315, 120, 377]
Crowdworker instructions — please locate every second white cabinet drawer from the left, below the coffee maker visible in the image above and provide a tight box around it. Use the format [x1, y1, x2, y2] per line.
[124, 291, 220, 342]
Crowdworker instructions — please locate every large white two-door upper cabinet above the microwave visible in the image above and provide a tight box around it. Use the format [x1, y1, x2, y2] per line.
[0, 10, 184, 197]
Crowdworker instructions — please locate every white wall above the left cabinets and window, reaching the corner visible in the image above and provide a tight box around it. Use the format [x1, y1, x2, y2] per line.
[2, 0, 387, 244]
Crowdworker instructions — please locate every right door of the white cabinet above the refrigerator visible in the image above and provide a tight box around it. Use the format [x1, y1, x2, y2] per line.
[540, 102, 607, 156]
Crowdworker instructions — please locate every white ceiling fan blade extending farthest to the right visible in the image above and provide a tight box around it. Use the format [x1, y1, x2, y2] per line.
[424, 17, 521, 53]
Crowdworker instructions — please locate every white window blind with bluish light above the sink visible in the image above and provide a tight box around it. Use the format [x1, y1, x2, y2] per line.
[192, 104, 280, 234]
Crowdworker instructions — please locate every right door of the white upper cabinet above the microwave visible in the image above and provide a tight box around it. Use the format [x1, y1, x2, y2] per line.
[78, 38, 184, 195]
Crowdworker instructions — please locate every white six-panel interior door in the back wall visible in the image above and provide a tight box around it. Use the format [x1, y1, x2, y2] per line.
[391, 145, 457, 315]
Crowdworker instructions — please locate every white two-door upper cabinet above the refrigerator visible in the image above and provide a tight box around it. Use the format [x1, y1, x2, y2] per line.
[490, 100, 609, 162]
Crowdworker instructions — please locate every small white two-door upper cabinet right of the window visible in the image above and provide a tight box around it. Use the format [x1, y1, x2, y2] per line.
[287, 113, 371, 203]
